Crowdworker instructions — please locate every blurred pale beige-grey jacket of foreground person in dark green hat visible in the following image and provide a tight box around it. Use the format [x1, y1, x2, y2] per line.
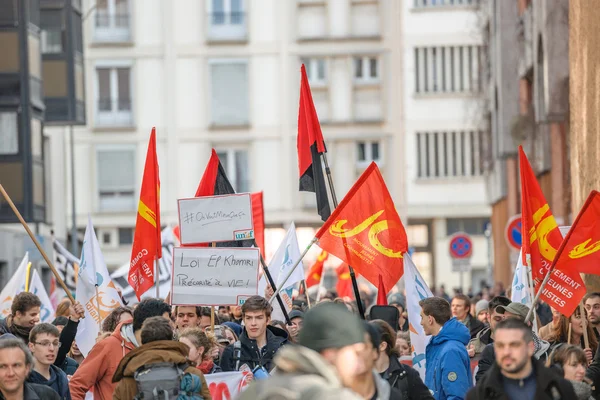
[239, 345, 362, 400]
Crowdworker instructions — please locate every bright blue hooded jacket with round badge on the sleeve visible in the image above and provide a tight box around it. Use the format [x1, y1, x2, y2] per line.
[425, 318, 473, 400]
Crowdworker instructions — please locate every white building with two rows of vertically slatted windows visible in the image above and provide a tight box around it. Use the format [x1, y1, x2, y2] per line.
[402, 0, 491, 293]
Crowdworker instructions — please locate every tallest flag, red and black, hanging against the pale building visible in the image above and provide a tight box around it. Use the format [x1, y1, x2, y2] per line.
[297, 65, 331, 221]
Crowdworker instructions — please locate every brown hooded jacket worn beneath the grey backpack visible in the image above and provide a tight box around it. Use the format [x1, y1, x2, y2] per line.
[112, 340, 211, 400]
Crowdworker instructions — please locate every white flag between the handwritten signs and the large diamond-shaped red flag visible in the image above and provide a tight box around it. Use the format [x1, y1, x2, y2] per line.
[258, 222, 304, 322]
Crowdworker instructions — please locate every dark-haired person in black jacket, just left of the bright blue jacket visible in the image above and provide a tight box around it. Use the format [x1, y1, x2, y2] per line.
[370, 319, 433, 400]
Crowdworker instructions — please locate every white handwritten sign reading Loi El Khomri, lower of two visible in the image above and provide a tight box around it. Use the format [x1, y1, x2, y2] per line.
[171, 247, 260, 306]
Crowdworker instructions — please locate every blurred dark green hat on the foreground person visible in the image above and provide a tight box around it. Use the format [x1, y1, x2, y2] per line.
[298, 303, 365, 352]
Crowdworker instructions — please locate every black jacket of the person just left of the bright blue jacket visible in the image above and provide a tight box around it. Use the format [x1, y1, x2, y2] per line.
[381, 356, 433, 400]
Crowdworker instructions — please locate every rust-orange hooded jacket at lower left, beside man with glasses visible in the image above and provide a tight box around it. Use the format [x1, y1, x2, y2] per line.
[69, 320, 137, 400]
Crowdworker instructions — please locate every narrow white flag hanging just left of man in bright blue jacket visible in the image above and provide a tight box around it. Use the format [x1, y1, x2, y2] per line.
[404, 253, 433, 381]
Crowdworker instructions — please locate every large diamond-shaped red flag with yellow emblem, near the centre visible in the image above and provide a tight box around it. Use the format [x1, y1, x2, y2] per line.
[316, 163, 408, 294]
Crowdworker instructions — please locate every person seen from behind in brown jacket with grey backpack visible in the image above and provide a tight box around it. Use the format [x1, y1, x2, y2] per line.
[113, 317, 211, 400]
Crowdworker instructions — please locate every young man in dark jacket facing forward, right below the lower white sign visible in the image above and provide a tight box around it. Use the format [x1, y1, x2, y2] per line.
[221, 296, 288, 372]
